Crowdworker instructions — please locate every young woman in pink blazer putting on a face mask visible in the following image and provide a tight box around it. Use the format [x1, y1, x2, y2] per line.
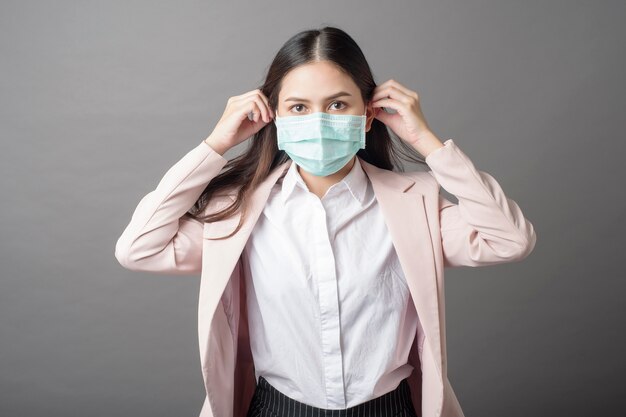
[115, 27, 536, 417]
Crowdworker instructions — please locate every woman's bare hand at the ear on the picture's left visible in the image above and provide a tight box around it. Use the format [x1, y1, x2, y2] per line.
[205, 89, 274, 154]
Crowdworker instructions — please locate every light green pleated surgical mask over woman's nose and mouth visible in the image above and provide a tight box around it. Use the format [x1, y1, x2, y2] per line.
[274, 107, 367, 177]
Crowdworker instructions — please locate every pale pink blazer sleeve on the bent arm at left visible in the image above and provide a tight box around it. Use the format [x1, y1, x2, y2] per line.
[115, 141, 228, 275]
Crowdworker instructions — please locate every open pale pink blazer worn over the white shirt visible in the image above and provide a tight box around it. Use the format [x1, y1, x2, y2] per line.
[115, 139, 536, 417]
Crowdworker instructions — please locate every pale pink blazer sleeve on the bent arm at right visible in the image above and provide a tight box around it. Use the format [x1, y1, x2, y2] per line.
[425, 139, 537, 267]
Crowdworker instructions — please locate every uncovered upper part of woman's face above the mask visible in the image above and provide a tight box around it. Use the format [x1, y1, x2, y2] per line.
[276, 61, 373, 131]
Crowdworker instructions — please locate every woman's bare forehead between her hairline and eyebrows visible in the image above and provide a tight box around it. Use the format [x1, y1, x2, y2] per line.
[278, 61, 358, 100]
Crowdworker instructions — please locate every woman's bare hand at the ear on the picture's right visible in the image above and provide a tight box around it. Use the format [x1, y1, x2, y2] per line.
[371, 79, 444, 156]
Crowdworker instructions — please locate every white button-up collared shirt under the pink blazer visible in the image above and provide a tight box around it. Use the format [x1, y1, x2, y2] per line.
[244, 157, 417, 409]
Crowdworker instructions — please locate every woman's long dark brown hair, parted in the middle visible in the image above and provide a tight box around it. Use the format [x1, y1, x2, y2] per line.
[189, 26, 426, 239]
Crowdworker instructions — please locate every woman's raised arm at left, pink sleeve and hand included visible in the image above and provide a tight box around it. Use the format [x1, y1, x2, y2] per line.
[115, 89, 274, 275]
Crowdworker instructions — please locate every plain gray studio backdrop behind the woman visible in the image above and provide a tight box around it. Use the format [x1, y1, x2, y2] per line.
[0, 0, 626, 417]
